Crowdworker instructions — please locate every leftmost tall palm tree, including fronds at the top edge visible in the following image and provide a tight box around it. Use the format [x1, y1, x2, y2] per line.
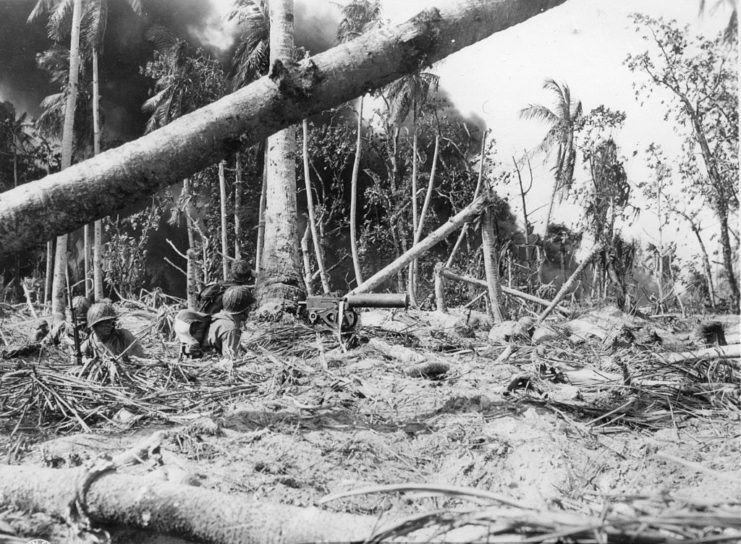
[29, 0, 82, 320]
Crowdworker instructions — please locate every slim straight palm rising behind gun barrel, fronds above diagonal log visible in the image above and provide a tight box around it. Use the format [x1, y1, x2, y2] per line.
[337, 0, 381, 285]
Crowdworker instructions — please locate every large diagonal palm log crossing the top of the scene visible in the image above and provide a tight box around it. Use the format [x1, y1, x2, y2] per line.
[0, 0, 565, 258]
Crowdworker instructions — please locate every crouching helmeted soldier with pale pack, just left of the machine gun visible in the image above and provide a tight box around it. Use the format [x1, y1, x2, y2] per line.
[173, 285, 254, 359]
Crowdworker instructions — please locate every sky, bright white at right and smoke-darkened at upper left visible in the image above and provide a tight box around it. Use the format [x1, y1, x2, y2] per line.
[0, 0, 730, 270]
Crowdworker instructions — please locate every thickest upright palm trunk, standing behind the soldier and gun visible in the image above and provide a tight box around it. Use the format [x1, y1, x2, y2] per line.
[256, 0, 304, 317]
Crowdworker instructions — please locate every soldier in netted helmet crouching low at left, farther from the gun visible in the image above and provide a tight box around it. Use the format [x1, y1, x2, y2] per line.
[81, 302, 146, 362]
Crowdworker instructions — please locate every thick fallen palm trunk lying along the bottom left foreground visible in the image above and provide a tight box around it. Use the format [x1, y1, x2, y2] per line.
[0, 465, 378, 544]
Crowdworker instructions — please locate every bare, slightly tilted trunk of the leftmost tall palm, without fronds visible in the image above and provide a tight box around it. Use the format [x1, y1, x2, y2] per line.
[49, 0, 81, 321]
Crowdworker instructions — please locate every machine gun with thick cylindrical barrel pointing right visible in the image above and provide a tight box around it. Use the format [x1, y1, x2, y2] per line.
[300, 293, 409, 332]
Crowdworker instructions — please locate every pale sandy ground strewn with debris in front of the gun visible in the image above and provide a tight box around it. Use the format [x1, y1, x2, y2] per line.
[2, 304, 741, 540]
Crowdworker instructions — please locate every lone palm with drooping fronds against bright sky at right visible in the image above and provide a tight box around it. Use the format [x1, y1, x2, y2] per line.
[520, 79, 583, 239]
